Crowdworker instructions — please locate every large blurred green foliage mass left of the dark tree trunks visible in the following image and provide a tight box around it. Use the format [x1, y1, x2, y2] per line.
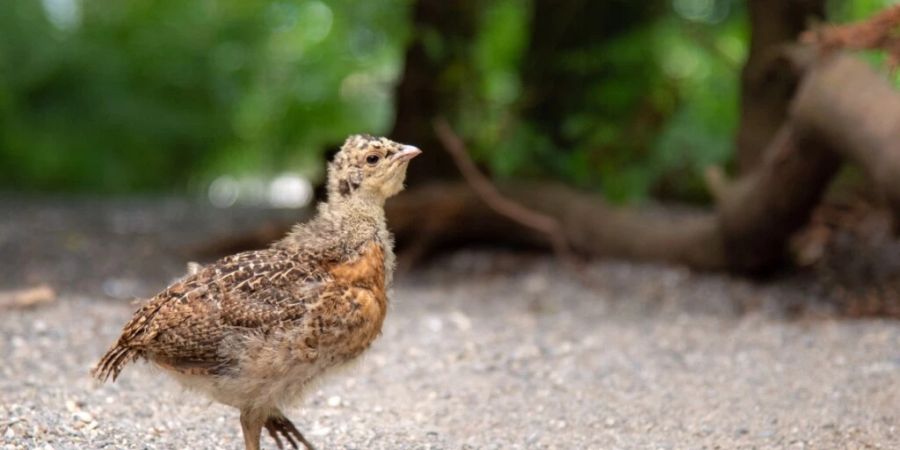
[0, 0, 408, 192]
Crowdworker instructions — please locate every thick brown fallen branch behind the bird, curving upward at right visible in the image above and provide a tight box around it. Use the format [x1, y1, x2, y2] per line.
[387, 124, 837, 273]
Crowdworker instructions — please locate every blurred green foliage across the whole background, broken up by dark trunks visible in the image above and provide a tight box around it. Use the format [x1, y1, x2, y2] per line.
[0, 0, 896, 201]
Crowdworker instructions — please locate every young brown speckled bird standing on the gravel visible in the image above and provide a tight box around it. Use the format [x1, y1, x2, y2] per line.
[92, 134, 422, 450]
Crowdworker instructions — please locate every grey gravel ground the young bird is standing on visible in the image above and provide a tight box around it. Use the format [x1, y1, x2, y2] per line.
[0, 199, 900, 449]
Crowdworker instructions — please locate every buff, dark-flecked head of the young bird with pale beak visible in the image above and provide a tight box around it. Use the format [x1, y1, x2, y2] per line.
[328, 134, 422, 203]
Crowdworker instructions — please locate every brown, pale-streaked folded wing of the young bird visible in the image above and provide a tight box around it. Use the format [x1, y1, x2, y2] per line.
[110, 249, 328, 372]
